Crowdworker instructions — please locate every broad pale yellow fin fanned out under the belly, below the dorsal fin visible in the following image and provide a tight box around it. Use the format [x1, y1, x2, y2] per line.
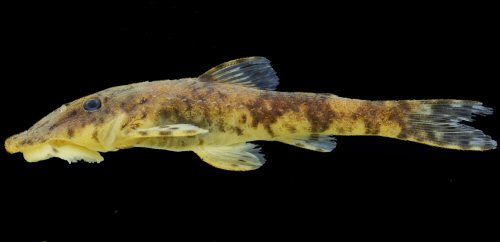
[193, 143, 266, 171]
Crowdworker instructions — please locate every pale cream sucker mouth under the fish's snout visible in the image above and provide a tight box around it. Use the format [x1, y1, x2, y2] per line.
[20, 140, 104, 163]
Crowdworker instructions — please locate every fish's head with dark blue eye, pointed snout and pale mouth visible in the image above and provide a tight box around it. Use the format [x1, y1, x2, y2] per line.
[5, 85, 146, 162]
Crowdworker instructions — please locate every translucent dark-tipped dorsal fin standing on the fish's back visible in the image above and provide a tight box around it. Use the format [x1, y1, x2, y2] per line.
[199, 56, 279, 90]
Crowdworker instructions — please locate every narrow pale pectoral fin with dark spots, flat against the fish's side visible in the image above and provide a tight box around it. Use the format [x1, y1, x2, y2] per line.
[128, 124, 208, 138]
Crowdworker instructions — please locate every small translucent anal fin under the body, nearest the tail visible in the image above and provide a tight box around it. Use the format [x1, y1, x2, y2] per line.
[280, 135, 337, 152]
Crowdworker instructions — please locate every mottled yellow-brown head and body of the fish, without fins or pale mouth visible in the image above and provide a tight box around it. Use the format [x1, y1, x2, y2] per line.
[6, 78, 418, 157]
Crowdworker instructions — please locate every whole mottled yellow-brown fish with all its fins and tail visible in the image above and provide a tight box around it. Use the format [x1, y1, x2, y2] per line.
[5, 56, 497, 171]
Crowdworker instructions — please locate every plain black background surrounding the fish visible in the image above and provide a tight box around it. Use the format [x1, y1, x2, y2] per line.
[0, 1, 500, 241]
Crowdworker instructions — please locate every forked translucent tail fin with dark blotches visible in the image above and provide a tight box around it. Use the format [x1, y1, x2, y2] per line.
[398, 100, 497, 151]
